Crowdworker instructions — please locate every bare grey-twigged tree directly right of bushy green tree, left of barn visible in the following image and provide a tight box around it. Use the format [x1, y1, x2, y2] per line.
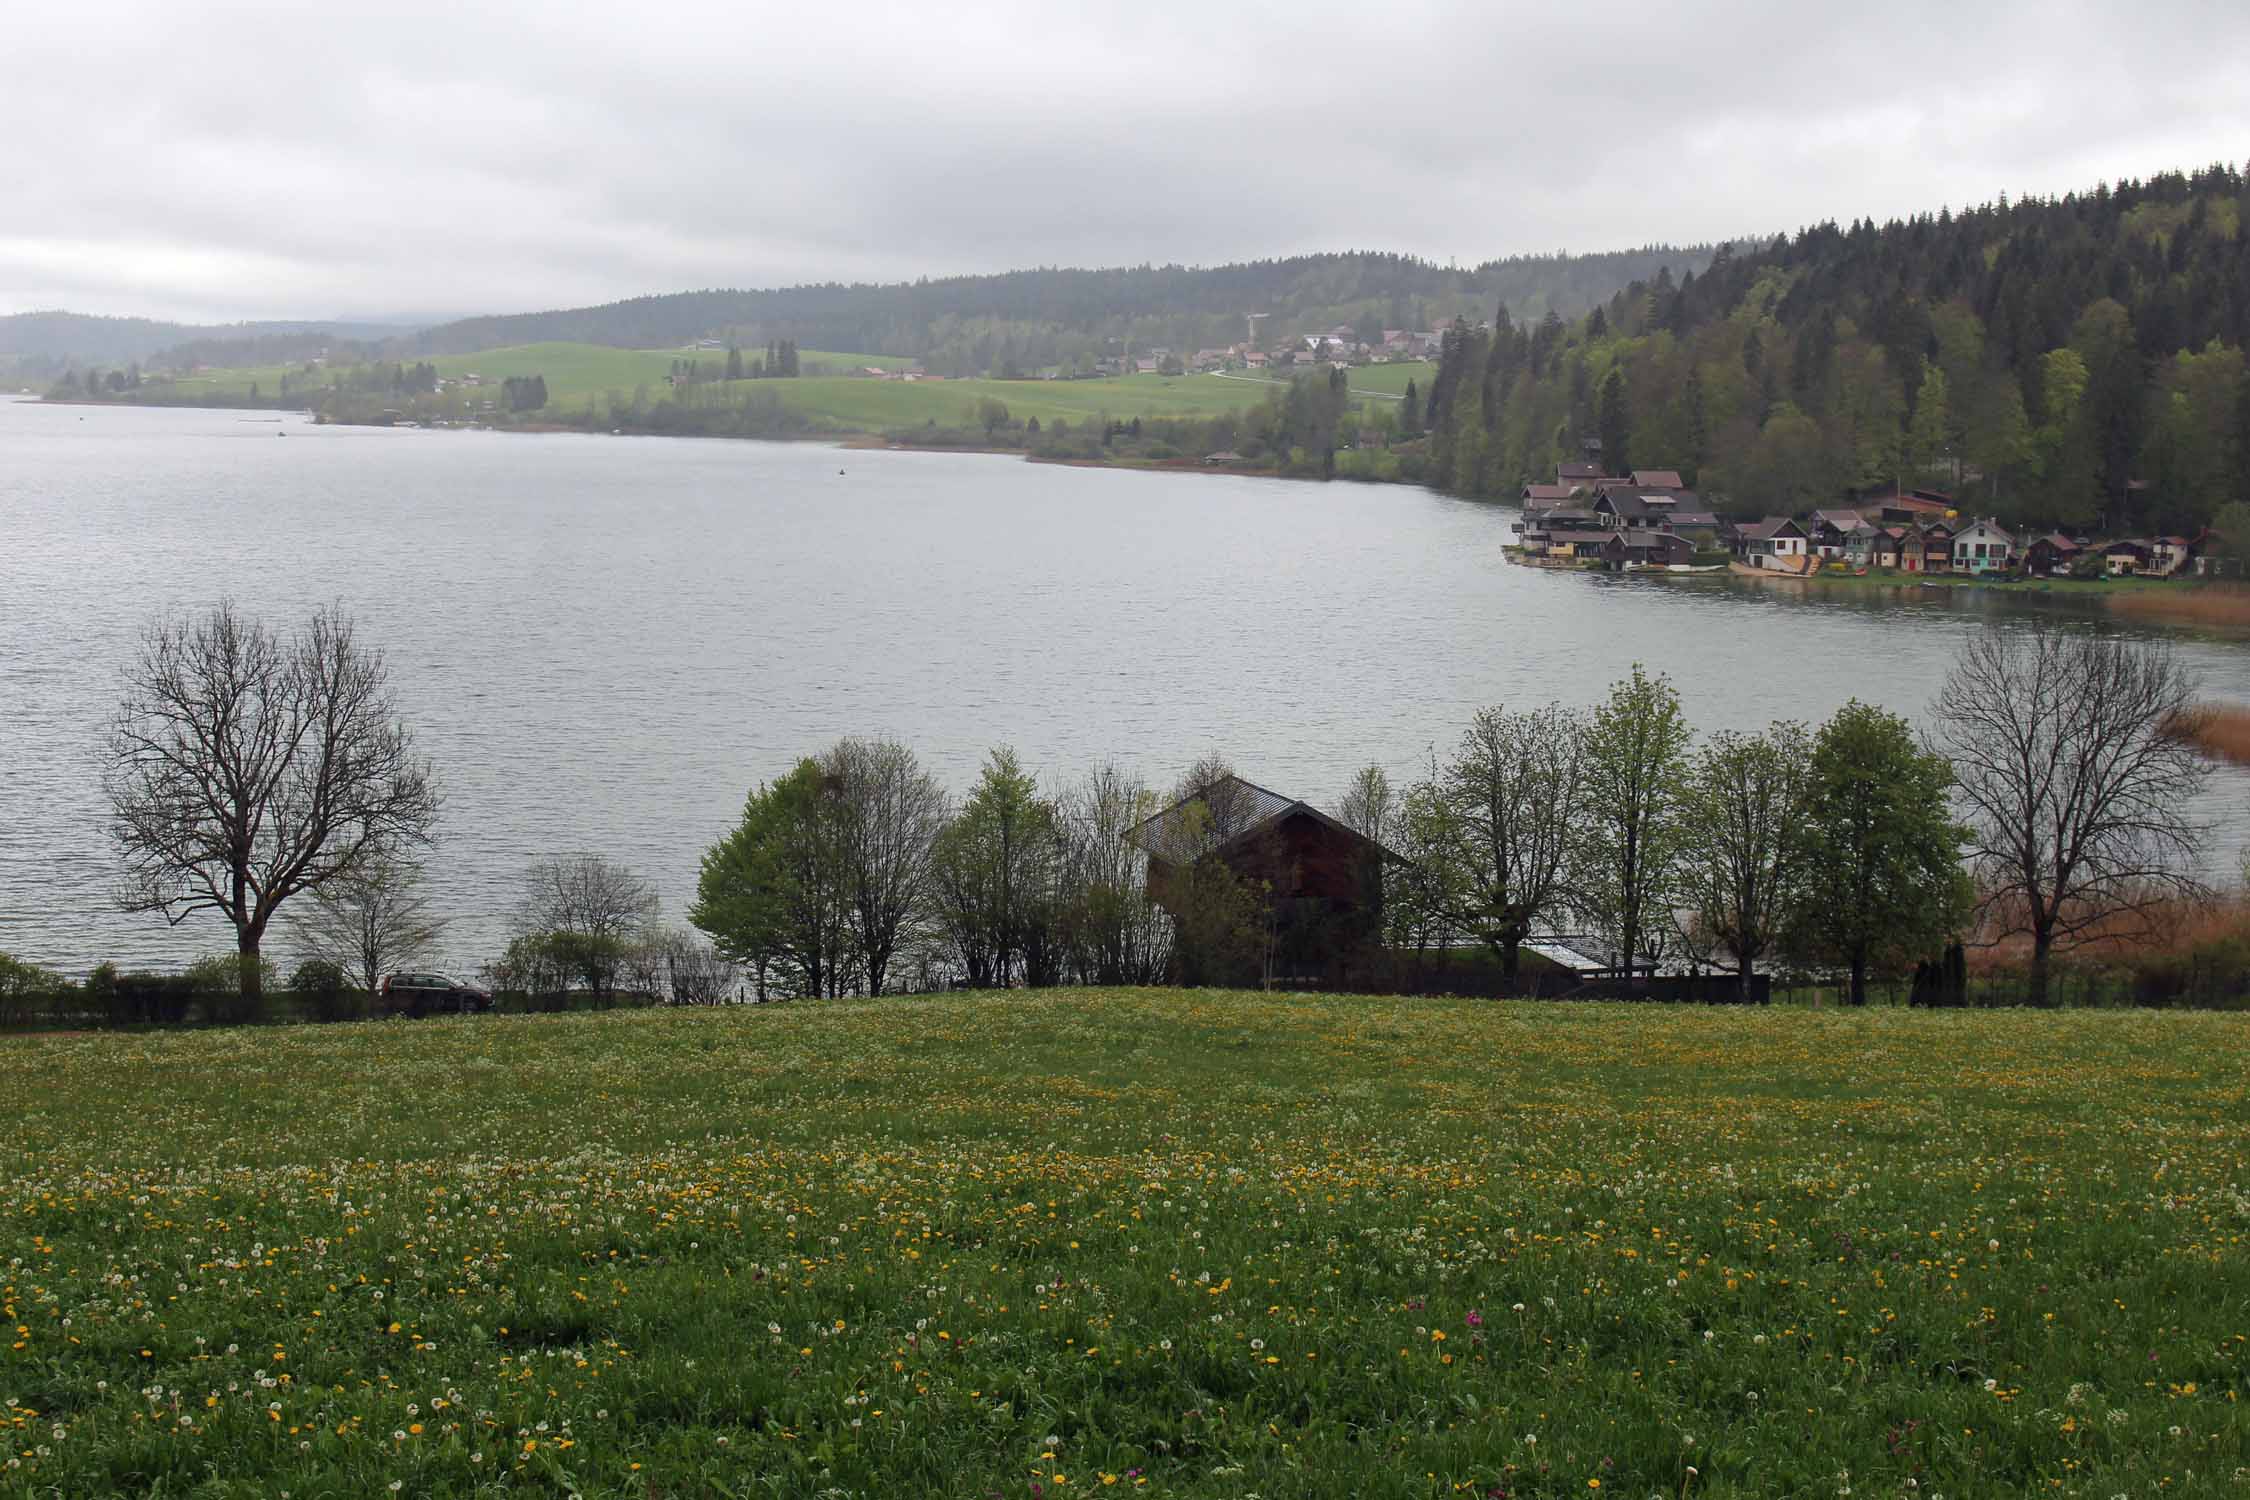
[821, 740, 947, 994]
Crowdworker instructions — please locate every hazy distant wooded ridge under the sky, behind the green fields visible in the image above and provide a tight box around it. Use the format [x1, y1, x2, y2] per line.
[387, 245, 1712, 373]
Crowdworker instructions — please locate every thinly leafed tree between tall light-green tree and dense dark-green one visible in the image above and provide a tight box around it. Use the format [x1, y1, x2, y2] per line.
[1681, 722, 1811, 996]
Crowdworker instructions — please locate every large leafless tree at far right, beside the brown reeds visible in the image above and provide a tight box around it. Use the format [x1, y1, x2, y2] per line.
[1931, 621, 2210, 1005]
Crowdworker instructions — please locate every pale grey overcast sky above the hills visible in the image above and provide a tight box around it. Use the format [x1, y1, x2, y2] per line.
[0, 0, 2250, 319]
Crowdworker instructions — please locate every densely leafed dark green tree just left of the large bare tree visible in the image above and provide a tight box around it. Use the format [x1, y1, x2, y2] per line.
[1784, 699, 1971, 1005]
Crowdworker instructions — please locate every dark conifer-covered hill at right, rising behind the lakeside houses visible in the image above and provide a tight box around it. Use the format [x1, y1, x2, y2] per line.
[1429, 166, 2250, 531]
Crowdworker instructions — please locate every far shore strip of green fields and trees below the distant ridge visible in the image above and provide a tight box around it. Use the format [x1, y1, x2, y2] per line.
[47, 344, 1436, 484]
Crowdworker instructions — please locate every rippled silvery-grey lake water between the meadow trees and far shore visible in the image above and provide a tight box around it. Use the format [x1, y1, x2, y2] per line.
[13, 403, 2250, 972]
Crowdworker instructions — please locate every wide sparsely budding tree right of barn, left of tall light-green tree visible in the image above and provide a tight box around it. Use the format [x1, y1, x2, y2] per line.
[1418, 704, 1586, 978]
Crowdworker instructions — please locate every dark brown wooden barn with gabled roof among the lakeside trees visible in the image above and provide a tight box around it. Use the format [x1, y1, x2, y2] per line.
[1125, 776, 1400, 985]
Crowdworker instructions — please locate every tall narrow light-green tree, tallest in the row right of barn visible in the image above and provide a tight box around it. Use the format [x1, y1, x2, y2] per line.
[1571, 661, 1690, 969]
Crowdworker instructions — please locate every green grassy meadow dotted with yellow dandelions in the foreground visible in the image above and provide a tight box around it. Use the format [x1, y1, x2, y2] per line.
[0, 992, 2250, 1500]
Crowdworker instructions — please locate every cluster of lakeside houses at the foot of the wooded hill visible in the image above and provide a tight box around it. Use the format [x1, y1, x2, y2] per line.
[1510, 443, 2234, 578]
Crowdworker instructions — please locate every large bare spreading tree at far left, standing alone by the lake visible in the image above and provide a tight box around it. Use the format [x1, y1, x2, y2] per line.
[104, 603, 439, 1007]
